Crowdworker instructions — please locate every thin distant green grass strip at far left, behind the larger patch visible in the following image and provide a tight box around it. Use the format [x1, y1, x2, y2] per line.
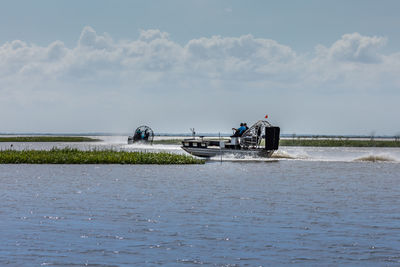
[0, 136, 101, 142]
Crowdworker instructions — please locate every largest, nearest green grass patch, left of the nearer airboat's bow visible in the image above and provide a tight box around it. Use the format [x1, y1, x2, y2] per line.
[0, 148, 205, 164]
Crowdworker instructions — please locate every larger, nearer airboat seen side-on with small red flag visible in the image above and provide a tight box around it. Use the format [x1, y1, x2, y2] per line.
[182, 120, 280, 158]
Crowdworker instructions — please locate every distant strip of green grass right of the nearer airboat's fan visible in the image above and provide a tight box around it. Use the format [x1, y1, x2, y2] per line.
[279, 139, 400, 147]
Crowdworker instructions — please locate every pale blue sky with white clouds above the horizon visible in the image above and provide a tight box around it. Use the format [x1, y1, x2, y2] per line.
[0, 0, 400, 135]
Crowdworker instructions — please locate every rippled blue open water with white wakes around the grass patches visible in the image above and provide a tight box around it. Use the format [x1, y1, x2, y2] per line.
[0, 137, 400, 266]
